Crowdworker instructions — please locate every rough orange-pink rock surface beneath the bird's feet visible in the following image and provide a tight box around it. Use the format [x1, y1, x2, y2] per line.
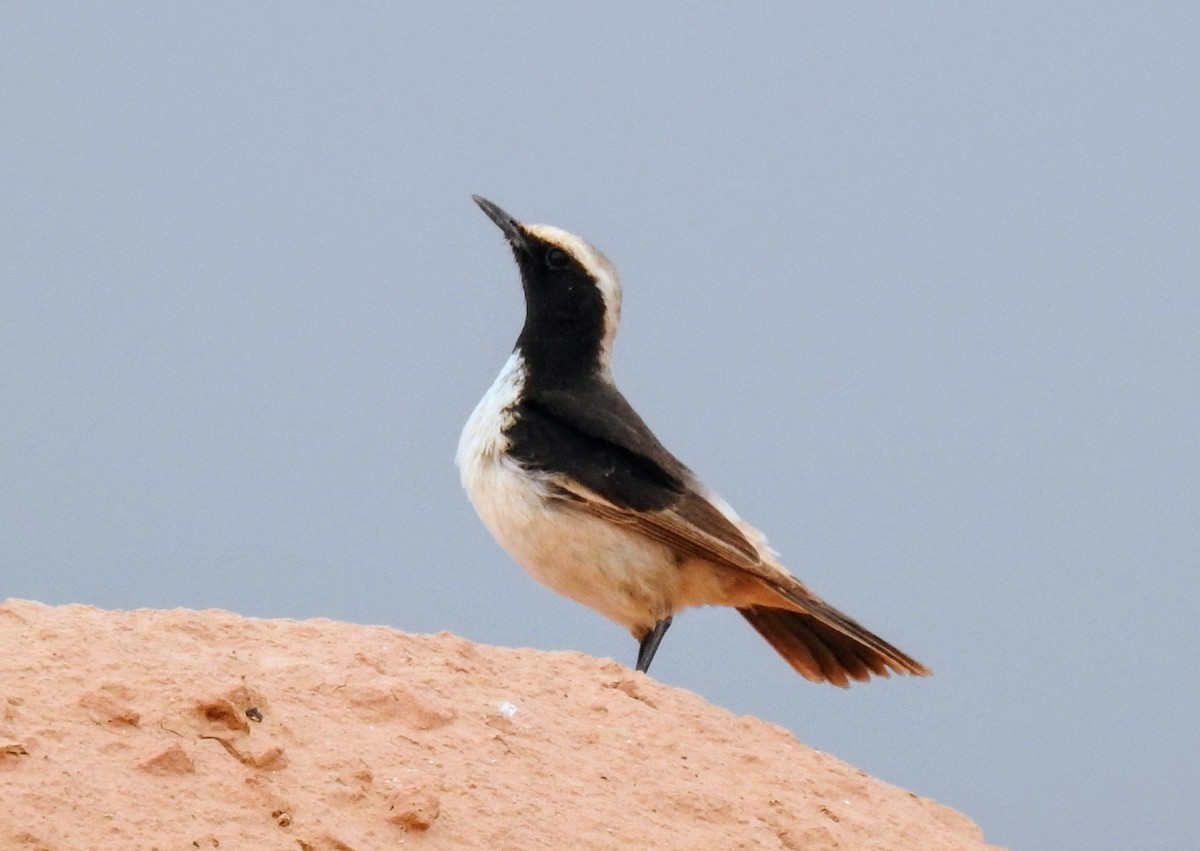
[0, 600, 990, 851]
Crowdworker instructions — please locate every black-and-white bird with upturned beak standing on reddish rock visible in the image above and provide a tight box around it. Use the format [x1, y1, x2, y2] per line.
[455, 196, 930, 688]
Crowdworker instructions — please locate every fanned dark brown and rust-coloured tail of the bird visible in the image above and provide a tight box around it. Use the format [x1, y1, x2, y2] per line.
[738, 600, 931, 688]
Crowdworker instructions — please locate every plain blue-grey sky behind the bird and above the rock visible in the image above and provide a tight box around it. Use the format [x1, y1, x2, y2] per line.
[0, 4, 1200, 851]
